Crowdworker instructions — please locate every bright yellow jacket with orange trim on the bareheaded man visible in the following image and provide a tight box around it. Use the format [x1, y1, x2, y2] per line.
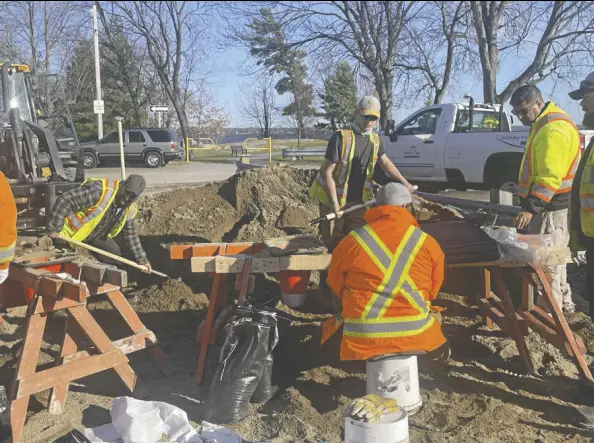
[518, 102, 580, 203]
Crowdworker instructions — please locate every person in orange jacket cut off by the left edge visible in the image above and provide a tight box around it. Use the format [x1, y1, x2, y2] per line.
[0, 172, 17, 284]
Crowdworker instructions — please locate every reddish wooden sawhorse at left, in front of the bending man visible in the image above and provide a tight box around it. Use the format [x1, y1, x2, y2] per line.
[3, 263, 174, 442]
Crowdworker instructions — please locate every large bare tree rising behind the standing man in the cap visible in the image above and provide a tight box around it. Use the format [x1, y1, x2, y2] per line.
[229, 1, 423, 127]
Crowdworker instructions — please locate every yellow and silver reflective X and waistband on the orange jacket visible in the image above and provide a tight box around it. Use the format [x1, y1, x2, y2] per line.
[343, 225, 435, 339]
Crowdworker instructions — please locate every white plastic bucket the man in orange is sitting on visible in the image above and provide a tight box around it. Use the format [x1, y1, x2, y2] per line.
[367, 355, 423, 415]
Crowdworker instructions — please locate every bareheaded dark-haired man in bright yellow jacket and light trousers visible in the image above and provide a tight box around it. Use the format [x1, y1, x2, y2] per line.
[511, 85, 580, 312]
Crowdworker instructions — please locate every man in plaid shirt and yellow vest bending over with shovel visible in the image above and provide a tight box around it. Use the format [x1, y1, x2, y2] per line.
[47, 174, 151, 273]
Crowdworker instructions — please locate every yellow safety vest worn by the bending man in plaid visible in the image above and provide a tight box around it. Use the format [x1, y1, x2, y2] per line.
[60, 178, 138, 241]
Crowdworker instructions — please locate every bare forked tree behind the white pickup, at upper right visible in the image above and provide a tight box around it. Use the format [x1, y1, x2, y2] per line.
[470, 1, 594, 103]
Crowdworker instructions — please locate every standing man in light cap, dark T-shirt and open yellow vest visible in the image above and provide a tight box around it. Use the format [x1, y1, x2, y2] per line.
[309, 96, 413, 248]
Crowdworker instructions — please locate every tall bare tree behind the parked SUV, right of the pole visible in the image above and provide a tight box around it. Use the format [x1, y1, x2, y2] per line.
[102, 1, 209, 143]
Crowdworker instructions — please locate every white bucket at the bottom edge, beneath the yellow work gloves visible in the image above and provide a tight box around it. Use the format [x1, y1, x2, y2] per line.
[344, 410, 409, 443]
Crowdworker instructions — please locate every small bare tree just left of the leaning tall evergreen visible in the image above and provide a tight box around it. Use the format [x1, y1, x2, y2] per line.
[240, 75, 280, 137]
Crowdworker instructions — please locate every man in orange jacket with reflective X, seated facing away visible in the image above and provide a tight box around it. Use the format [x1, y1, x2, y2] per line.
[327, 183, 446, 360]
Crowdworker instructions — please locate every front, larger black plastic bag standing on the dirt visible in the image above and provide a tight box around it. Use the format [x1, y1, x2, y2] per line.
[206, 317, 271, 423]
